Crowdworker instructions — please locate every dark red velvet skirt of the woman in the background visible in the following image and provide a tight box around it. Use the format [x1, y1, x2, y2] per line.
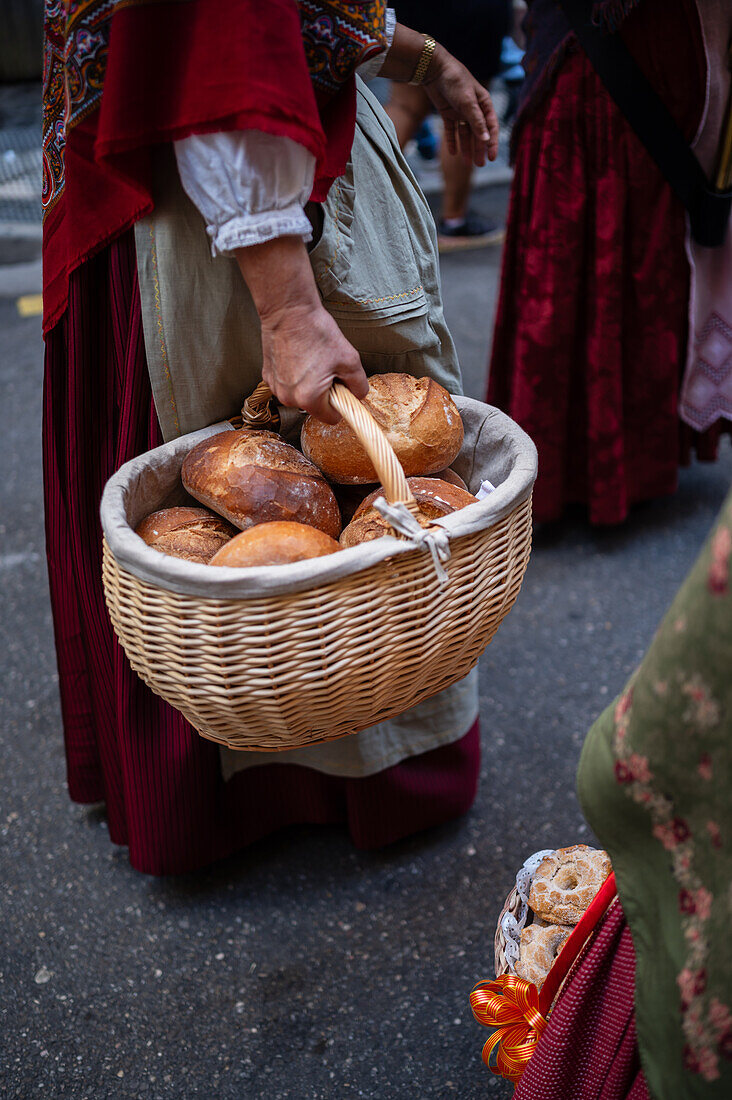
[488, 0, 730, 524]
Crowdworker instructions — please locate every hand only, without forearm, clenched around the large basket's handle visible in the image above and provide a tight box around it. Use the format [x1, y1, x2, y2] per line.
[262, 303, 369, 424]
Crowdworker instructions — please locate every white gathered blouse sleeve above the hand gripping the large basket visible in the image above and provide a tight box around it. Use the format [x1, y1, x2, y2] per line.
[175, 130, 315, 255]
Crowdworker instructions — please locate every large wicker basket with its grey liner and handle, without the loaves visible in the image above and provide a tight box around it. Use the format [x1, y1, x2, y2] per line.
[101, 384, 536, 751]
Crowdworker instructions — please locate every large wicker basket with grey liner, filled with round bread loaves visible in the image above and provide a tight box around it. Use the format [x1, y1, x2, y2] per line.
[101, 374, 536, 751]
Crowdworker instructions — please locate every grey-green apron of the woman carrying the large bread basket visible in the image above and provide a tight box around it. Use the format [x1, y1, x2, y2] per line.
[135, 80, 478, 778]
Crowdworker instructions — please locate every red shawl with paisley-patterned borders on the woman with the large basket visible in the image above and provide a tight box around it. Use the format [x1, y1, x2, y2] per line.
[43, 0, 386, 331]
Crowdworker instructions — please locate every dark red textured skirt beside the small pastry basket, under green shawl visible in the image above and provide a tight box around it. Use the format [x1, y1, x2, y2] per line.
[514, 904, 649, 1100]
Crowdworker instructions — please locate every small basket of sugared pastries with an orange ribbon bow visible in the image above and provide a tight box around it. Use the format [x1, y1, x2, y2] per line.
[470, 844, 615, 1084]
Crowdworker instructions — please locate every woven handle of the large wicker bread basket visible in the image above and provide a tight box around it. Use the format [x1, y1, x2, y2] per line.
[241, 382, 419, 515]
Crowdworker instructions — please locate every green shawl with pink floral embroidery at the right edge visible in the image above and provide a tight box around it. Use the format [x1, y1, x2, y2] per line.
[579, 493, 732, 1100]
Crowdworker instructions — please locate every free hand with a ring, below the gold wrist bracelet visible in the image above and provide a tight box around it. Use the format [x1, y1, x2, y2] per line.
[423, 45, 499, 166]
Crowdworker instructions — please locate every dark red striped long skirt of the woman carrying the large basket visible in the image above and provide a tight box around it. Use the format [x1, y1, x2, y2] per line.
[43, 232, 480, 875]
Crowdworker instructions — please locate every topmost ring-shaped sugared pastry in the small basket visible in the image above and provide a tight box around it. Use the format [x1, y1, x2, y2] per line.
[528, 844, 612, 924]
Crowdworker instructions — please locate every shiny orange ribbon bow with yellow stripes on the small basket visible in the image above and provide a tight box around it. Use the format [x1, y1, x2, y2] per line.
[470, 974, 547, 1084]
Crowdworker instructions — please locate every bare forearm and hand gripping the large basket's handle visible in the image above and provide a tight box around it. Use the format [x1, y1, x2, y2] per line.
[237, 237, 369, 424]
